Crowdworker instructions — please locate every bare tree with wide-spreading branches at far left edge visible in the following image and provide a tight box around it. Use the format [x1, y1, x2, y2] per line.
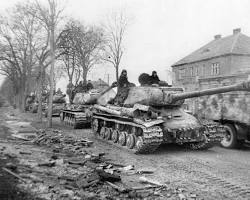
[0, 4, 39, 111]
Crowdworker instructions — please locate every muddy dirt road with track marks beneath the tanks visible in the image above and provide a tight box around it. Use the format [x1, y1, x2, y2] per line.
[55, 119, 250, 200]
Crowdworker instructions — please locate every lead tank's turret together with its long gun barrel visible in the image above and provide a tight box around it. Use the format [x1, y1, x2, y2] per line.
[124, 82, 250, 106]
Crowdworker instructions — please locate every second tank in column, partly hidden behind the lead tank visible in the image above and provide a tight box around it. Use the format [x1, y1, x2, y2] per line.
[60, 86, 115, 129]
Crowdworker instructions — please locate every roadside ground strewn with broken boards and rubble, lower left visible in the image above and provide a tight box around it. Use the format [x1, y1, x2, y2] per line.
[0, 109, 201, 200]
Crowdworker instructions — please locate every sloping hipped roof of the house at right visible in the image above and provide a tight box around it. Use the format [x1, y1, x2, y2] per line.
[172, 32, 250, 66]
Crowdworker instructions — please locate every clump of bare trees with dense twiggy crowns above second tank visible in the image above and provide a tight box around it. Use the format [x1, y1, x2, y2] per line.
[59, 20, 104, 95]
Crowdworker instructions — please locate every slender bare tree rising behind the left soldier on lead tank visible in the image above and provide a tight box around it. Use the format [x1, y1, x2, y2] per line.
[102, 12, 129, 81]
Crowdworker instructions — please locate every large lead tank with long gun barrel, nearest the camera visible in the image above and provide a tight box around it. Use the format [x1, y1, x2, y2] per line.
[92, 82, 250, 153]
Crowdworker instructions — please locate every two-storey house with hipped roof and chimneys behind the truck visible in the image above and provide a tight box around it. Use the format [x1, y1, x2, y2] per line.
[172, 28, 250, 112]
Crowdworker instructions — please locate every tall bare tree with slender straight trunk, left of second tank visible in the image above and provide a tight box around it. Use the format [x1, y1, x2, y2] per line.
[35, 0, 63, 127]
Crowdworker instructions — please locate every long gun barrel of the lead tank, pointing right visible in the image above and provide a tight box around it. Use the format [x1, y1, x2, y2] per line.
[170, 81, 250, 104]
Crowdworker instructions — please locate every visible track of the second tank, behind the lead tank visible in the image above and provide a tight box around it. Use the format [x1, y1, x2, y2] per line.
[60, 110, 91, 129]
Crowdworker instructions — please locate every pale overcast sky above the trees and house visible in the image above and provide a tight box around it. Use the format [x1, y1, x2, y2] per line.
[0, 0, 250, 89]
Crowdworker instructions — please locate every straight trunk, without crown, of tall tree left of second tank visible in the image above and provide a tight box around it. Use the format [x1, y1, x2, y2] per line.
[48, 24, 55, 128]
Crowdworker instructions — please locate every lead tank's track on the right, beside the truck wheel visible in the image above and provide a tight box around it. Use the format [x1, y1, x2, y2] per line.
[186, 120, 226, 150]
